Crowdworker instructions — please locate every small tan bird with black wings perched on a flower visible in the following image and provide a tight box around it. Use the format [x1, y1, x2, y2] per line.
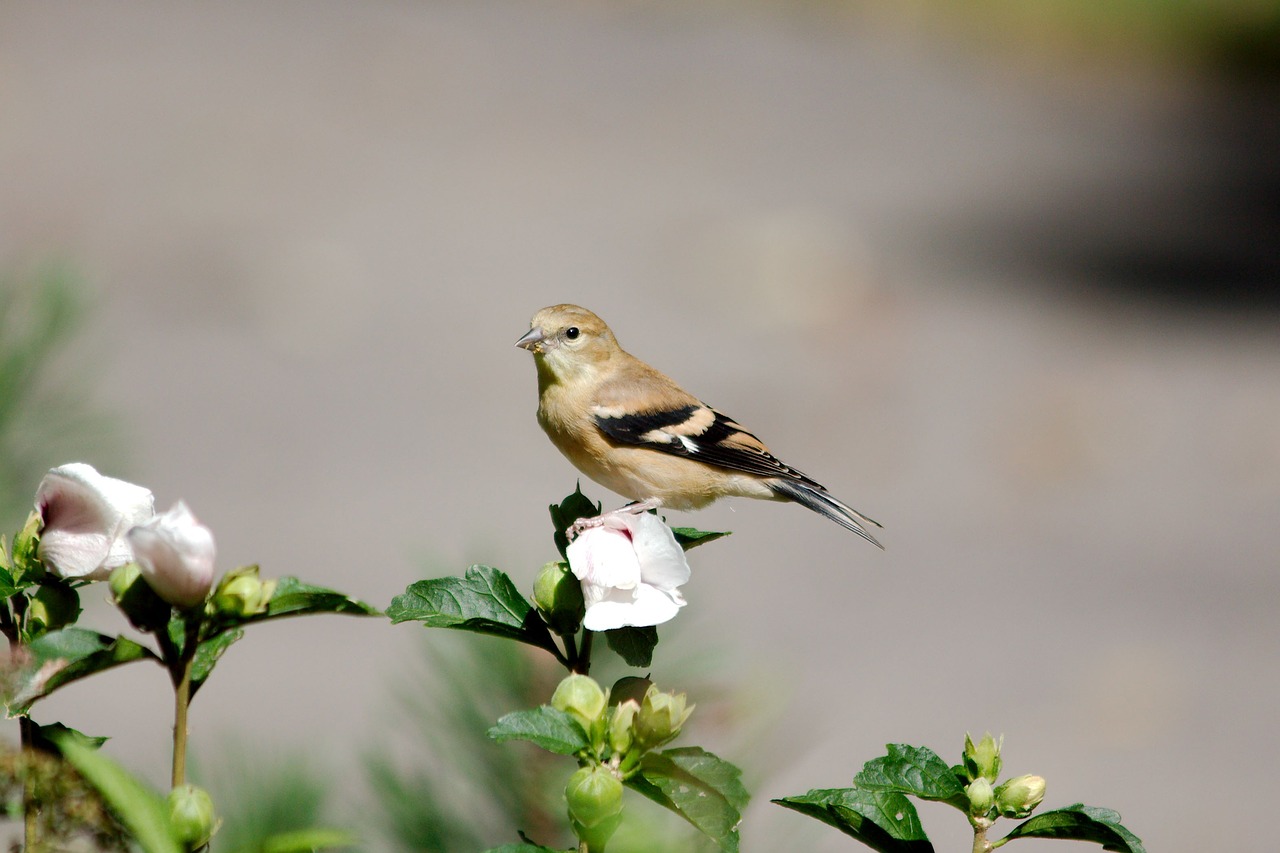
[516, 305, 884, 549]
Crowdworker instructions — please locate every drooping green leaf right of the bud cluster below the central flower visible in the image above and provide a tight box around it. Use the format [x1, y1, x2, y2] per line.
[626, 747, 750, 853]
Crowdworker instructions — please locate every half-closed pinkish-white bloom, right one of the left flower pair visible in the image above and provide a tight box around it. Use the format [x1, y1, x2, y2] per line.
[129, 501, 214, 607]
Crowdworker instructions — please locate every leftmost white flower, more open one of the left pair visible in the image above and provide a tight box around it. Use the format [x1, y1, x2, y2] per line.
[36, 462, 155, 580]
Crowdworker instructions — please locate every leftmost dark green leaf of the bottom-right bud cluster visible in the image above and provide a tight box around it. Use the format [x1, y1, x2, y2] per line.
[773, 788, 933, 853]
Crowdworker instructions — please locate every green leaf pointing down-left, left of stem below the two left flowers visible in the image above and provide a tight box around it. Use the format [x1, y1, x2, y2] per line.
[6, 628, 160, 717]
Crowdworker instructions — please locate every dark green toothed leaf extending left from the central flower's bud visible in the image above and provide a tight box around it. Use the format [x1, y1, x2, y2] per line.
[387, 566, 558, 653]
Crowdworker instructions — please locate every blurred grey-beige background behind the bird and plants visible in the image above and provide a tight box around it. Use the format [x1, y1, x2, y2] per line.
[0, 0, 1280, 853]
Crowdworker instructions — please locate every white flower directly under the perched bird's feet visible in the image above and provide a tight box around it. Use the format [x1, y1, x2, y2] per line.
[568, 504, 690, 631]
